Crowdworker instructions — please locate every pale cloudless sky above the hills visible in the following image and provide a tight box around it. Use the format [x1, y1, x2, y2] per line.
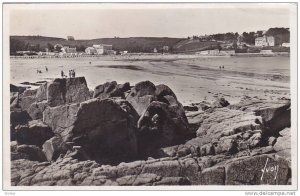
[8, 4, 290, 39]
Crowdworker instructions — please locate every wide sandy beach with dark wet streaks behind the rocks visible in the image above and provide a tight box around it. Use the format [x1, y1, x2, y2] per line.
[10, 55, 290, 105]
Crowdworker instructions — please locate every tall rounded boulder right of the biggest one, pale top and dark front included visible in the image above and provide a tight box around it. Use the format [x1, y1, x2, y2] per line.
[126, 81, 192, 155]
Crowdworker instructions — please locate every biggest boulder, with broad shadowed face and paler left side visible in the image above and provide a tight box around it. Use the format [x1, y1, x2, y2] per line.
[44, 98, 138, 162]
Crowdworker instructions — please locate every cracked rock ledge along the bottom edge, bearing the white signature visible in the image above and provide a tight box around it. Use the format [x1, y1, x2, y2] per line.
[12, 155, 289, 186]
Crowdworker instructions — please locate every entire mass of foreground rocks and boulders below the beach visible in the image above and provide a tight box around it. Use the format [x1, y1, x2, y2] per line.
[11, 78, 292, 186]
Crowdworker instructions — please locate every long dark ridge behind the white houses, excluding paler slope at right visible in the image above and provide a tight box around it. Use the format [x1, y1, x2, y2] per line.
[10, 36, 182, 52]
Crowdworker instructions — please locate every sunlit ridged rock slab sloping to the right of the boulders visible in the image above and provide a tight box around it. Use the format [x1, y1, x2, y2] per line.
[160, 99, 290, 159]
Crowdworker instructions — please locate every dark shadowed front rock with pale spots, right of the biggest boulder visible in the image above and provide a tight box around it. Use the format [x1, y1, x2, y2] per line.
[138, 101, 190, 154]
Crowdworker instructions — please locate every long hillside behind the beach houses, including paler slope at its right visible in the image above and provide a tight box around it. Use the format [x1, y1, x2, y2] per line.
[11, 36, 217, 53]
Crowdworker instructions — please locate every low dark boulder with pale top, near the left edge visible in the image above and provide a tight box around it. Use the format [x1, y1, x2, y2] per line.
[14, 120, 54, 146]
